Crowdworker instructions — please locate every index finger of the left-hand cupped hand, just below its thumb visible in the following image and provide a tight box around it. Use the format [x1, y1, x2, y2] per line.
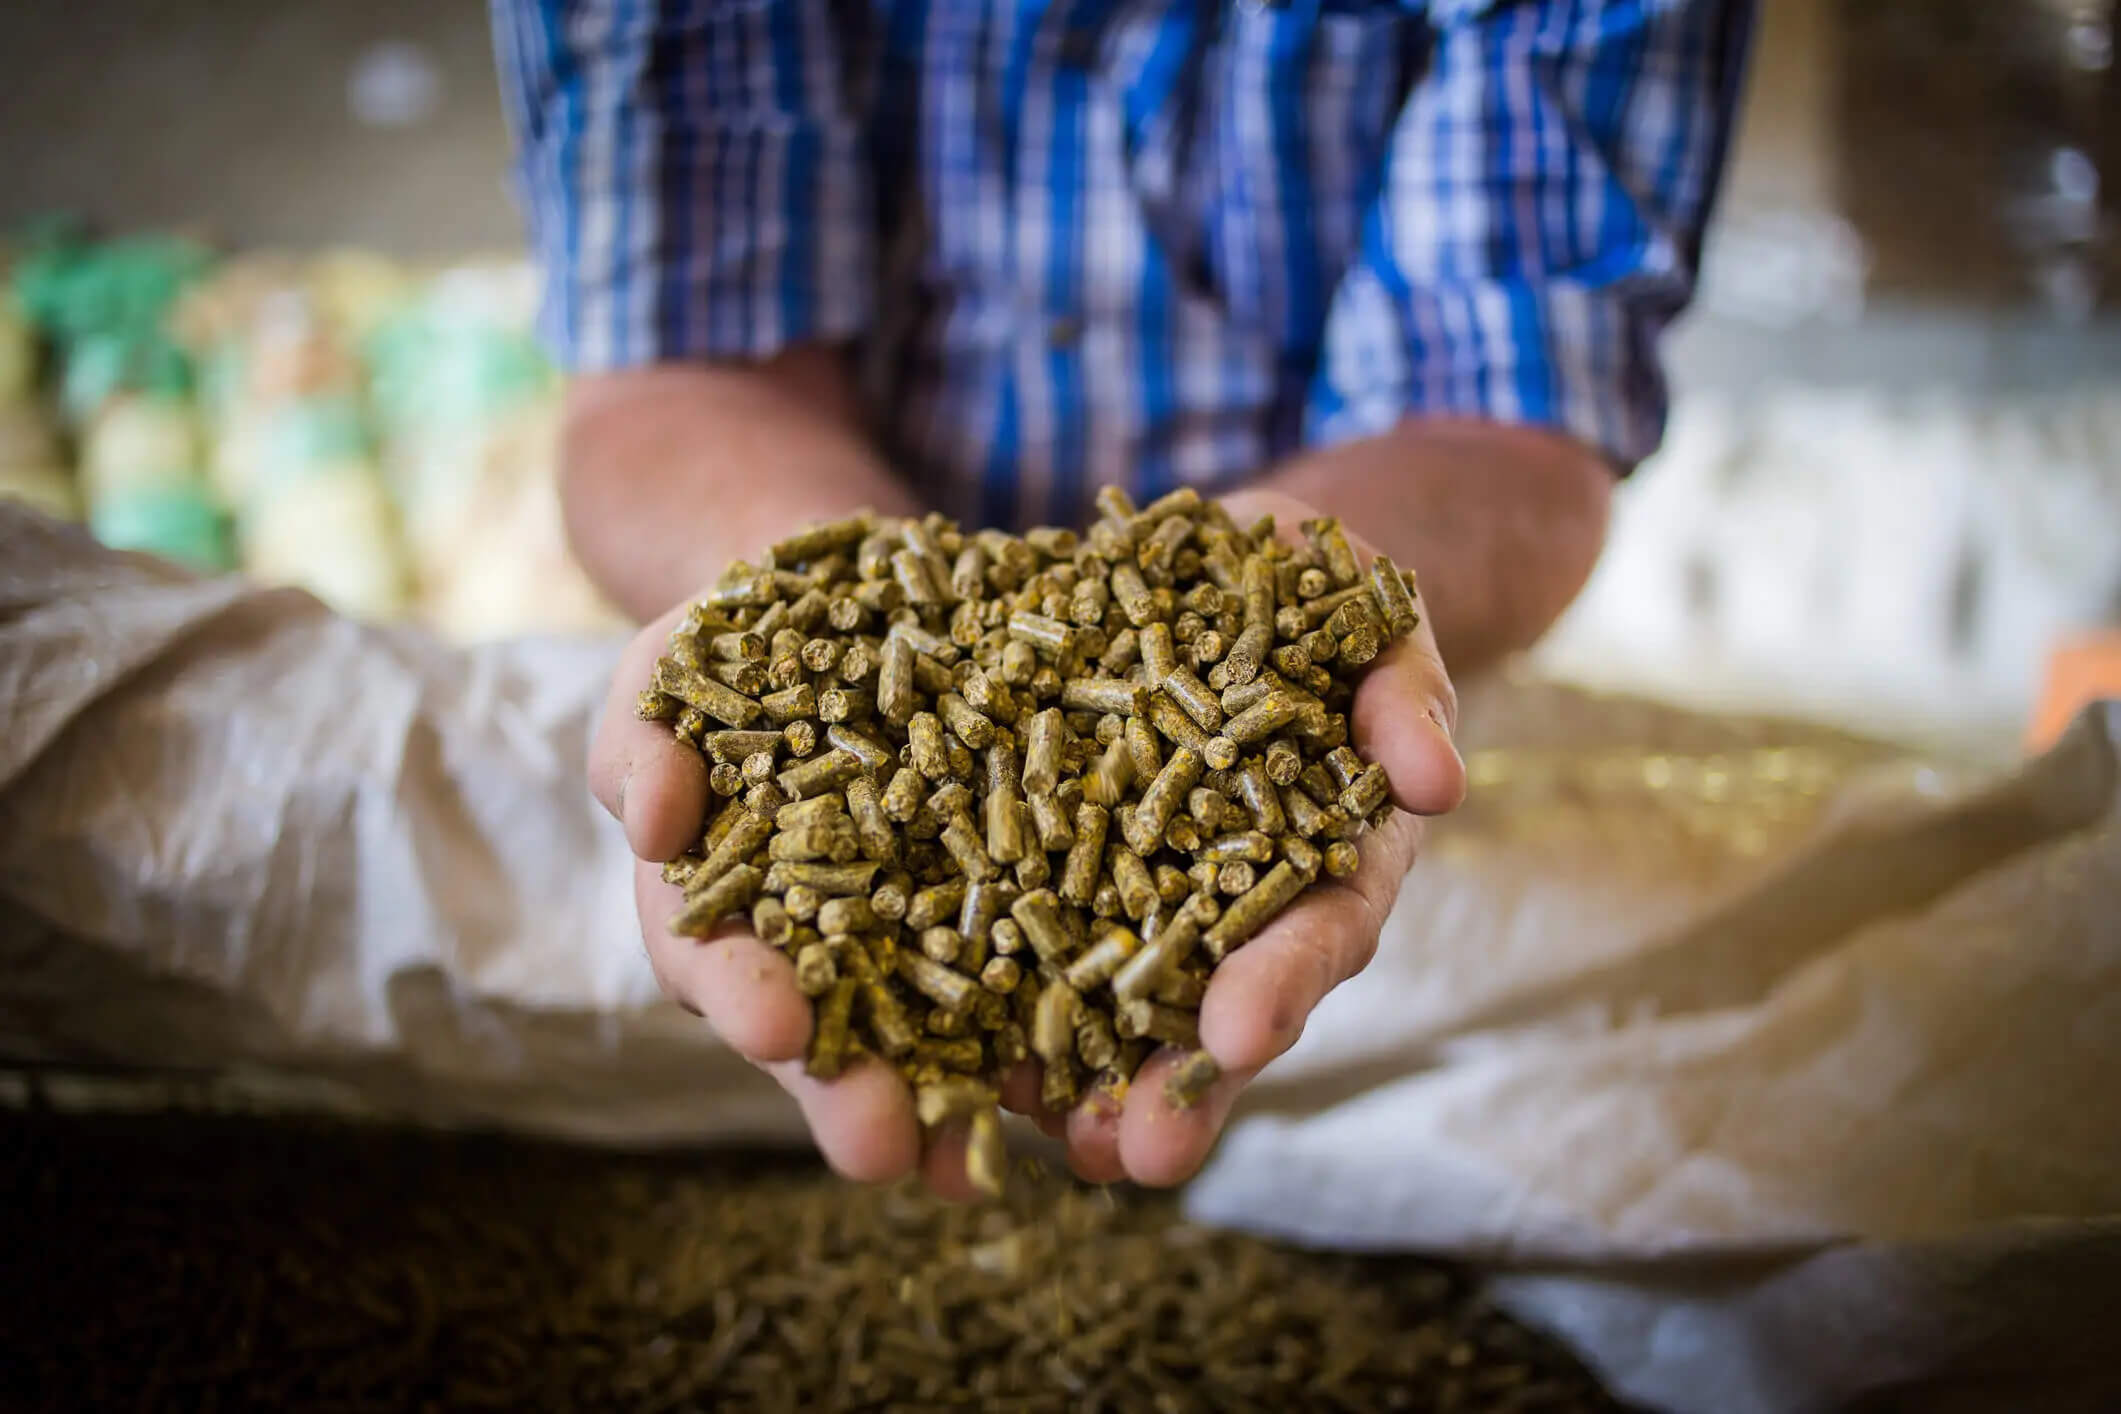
[634, 863, 810, 1062]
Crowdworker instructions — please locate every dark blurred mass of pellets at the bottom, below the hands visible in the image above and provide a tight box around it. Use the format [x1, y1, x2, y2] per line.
[0, 1111, 1618, 1414]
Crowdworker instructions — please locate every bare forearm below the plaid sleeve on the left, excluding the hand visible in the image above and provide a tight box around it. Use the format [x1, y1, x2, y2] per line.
[560, 348, 918, 619]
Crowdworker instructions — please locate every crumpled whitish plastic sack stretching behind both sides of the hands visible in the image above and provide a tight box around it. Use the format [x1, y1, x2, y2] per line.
[0, 509, 2121, 1414]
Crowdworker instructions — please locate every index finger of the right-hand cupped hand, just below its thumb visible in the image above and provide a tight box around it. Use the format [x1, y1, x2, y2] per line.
[1200, 812, 1421, 1071]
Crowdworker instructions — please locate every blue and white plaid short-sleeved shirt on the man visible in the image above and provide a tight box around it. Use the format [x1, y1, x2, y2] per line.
[492, 0, 1750, 524]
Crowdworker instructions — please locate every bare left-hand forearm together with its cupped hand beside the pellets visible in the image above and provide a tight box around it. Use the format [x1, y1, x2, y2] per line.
[562, 348, 965, 1191]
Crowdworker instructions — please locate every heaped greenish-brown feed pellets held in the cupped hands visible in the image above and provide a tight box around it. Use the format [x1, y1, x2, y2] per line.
[638, 488, 1419, 1191]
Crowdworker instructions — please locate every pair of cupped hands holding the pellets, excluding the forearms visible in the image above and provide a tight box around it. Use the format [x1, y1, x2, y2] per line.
[590, 492, 1466, 1198]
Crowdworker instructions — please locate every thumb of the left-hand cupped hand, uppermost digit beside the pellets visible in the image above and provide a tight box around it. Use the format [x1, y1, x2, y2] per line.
[590, 608, 706, 861]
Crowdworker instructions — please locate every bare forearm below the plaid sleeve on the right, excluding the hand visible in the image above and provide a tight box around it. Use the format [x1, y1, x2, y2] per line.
[1260, 420, 1612, 674]
